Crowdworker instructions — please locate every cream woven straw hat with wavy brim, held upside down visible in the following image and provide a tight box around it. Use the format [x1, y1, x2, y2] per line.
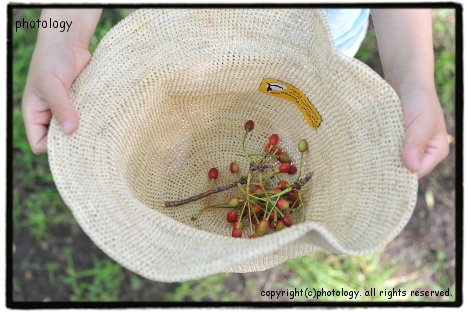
[48, 9, 418, 282]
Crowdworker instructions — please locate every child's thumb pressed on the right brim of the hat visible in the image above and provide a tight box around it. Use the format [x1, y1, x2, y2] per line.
[402, 116, 431, 172]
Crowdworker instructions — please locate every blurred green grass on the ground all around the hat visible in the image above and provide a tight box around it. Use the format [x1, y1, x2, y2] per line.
[13, 9, 455, 302]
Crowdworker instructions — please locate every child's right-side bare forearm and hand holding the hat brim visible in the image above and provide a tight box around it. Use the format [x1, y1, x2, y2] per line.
[371, 9, 449, 178]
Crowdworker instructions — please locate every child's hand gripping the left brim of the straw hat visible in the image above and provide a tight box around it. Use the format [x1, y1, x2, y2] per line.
[22, 40, 91, 154]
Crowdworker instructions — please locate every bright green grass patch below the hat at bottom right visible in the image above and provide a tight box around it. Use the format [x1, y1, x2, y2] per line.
[165, 246, 455, 302]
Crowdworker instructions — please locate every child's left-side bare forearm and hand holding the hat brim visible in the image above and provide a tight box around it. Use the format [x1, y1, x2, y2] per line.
[22, 9, 102, 154]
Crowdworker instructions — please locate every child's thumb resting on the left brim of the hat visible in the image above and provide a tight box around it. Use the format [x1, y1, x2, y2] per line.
[42, 79, 78, 134]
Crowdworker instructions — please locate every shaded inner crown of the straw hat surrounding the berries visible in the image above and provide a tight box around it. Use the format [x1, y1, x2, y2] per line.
[121, 90, 326, 236]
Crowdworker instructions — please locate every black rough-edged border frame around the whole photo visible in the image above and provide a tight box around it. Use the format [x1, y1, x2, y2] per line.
[6, 2, 464, 309]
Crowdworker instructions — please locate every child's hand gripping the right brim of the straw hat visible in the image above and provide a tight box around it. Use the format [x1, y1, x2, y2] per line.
[396, 82, 449, 178]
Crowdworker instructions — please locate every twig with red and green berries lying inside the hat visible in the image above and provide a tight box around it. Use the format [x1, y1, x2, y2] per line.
[165, 120, 313, 238]
